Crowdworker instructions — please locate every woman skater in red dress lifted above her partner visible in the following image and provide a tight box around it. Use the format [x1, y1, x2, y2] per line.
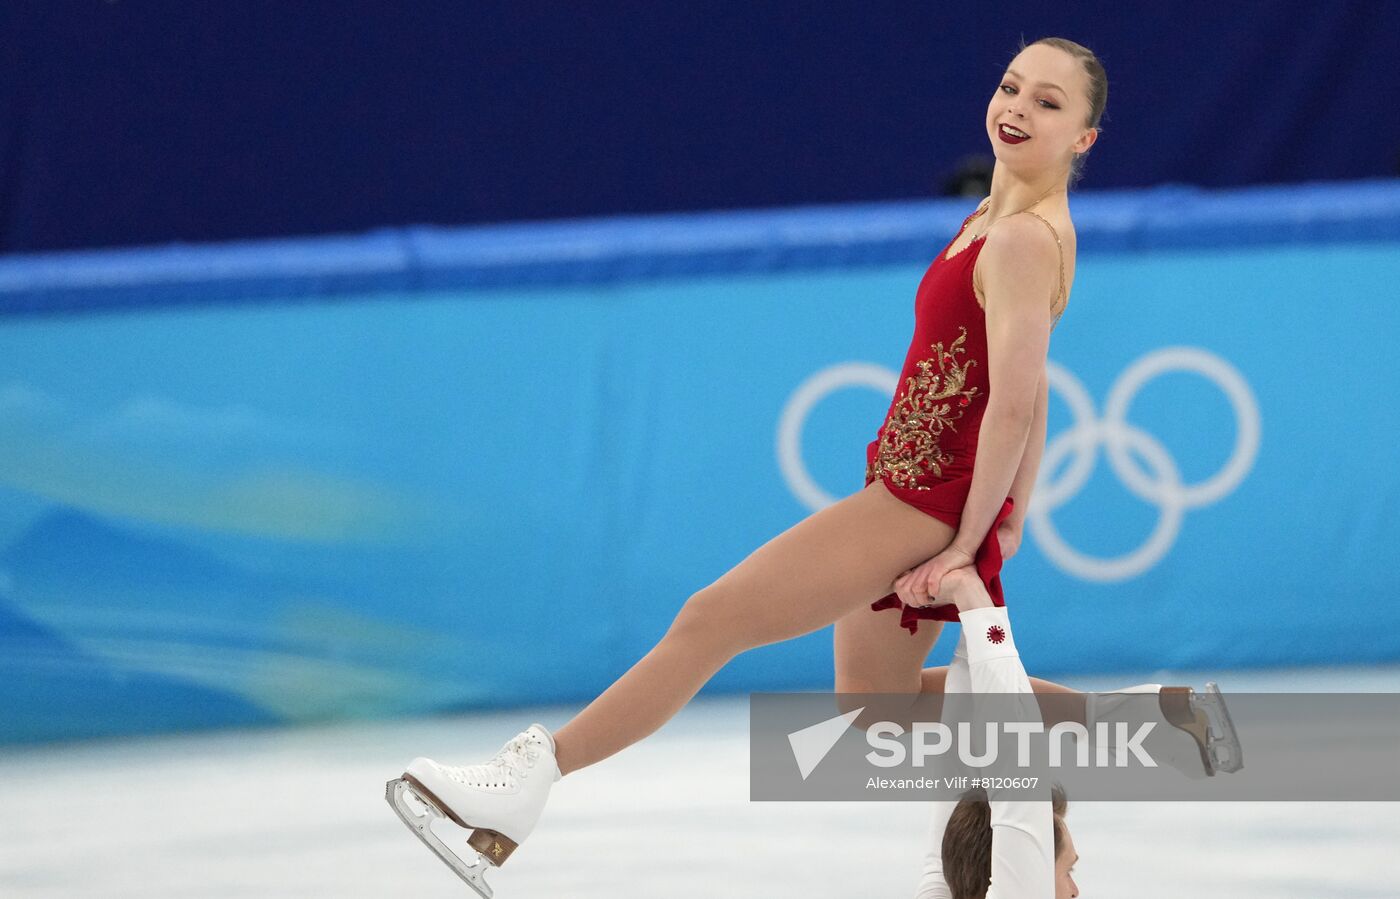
[389, 38, 1107, 895]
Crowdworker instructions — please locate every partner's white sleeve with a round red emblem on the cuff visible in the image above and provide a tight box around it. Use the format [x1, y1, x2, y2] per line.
[959, 606, 1054, 899]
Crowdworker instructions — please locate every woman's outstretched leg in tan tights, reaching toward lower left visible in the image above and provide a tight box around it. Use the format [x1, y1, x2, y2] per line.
[554, 480, 952, 774]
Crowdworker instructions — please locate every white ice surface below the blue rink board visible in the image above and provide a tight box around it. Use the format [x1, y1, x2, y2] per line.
[0, 668, 1400, 899]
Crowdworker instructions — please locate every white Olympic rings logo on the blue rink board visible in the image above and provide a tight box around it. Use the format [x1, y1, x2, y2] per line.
[777, 346, 1263, 583]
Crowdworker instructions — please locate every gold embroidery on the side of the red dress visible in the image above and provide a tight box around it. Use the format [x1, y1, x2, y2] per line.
[865, 326, 977, 490]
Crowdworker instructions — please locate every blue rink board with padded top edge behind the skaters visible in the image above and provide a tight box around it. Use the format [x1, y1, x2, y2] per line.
[0, 182, 1400, 742]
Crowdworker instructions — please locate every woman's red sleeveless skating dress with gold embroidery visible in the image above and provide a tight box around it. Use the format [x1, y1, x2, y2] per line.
[865, 197, 1064, 634]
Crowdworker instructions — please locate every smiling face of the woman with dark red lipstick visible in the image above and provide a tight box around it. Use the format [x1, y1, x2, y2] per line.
[987, 43, 1099, 178]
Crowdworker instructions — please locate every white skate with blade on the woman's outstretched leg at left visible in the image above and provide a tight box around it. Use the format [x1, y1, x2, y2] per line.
[385, 724, 560, 899]
